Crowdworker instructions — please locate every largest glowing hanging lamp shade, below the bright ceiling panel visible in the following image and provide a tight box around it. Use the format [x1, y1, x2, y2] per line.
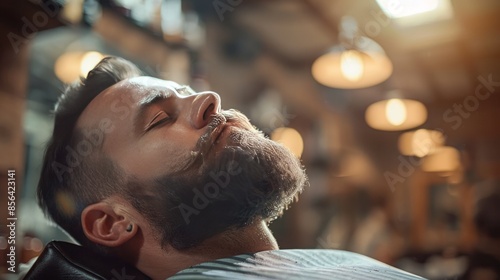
[312, 36, 393, 89]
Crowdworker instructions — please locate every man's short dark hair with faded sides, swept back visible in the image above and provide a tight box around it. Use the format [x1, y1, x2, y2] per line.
[37, 57, 141, 252]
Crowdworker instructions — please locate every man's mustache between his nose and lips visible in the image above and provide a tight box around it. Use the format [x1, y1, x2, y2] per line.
[176, 109, 259, 173]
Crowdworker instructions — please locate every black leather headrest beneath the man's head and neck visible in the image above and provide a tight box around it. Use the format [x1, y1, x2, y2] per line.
[24, 241, 151, 280]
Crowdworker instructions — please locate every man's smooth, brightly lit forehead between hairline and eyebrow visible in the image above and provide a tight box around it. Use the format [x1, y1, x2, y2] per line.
[76, 76, 182, 127]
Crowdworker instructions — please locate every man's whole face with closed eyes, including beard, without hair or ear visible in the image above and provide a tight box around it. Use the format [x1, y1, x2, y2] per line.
[77, 77, 306, 248]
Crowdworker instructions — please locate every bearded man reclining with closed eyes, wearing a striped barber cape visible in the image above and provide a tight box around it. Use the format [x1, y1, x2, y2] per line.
[34, 57, 426, 279]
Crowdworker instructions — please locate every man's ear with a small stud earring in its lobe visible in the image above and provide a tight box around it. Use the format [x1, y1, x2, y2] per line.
[81, 202, 137, 247]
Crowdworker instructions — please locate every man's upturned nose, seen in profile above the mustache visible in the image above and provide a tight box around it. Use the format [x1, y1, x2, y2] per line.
[190, 91, 221, 129]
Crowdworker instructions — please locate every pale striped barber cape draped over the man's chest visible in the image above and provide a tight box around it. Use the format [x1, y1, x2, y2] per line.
[168, 249, 424, 280]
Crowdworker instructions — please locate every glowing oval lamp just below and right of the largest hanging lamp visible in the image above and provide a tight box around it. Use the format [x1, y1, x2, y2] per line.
[365, 99, 427, 131]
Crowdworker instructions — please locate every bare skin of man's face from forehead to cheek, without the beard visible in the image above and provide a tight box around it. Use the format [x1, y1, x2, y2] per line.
[77, 77, 252, 182]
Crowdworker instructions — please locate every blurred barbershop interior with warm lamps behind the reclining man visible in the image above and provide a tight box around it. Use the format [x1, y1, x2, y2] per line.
[0, 0, 500, 279]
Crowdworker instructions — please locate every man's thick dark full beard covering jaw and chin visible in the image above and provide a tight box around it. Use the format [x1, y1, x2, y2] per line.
[125, 109, 307, 250]
